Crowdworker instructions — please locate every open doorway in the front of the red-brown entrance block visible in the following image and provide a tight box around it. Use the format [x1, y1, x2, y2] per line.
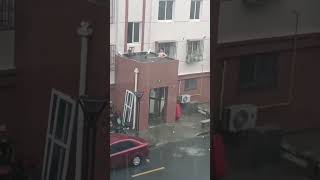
[149, 87, 168, 127]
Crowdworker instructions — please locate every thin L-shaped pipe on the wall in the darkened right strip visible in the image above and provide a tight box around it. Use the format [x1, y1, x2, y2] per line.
[258, 10, 300, 109]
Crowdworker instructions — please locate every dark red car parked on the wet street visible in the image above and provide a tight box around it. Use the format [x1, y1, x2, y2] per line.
[110, 133, 149, 168]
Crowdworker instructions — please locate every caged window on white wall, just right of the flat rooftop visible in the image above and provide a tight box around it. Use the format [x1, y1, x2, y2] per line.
[186, 40, 203, 63]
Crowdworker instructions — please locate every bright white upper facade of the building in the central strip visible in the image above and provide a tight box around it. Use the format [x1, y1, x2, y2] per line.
[110, 0, 210, 84]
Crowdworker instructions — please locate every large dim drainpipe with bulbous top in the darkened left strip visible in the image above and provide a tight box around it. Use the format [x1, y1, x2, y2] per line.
[75, 21, 93, 180]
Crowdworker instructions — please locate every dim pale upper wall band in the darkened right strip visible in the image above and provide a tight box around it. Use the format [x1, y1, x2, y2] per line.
[218, 0, 320, 43]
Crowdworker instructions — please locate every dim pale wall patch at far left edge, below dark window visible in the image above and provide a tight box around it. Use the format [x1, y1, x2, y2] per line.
[0, 31, 15, 70]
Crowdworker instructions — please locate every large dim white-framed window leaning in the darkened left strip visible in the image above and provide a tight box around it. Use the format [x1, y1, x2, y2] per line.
[42, 89, 76, 180]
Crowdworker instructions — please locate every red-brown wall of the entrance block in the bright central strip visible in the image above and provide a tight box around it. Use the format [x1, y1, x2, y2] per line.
[111, 57, 178, 130]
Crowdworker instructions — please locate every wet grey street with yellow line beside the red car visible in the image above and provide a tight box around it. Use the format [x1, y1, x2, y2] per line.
[110, 136, 210, 180]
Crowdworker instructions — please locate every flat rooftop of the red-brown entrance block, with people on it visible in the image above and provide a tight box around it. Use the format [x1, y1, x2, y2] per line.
[123, 52, 175, 63]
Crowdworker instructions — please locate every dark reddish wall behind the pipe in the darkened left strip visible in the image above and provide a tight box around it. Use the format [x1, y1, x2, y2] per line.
[14, 0, 108, 179]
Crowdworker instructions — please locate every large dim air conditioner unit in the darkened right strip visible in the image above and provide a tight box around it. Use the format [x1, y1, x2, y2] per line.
[223, 104, 257, 132]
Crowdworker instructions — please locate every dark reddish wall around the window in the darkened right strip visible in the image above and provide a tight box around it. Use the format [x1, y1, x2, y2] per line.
[218, 35, 320, 129]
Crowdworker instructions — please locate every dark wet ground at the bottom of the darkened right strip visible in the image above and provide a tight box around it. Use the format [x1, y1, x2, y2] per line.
[224, 131, 320, 180]
